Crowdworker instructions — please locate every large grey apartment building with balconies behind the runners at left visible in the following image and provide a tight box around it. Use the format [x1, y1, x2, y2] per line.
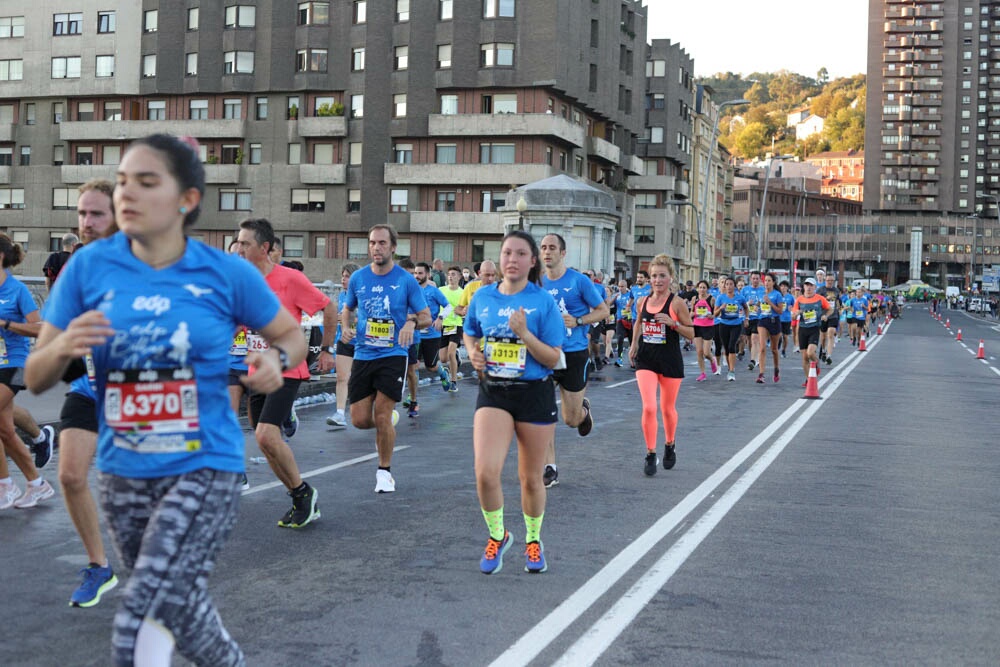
[0, 0, 648, 280]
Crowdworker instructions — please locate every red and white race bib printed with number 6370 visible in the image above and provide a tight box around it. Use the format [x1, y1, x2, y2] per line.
[104, 368, 201, 454]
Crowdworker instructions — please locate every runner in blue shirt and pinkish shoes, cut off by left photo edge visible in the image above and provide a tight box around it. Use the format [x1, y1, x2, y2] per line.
[0, 232, 55, 510]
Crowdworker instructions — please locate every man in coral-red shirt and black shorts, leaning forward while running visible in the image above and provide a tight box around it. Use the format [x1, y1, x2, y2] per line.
[237, 218, 337, 528]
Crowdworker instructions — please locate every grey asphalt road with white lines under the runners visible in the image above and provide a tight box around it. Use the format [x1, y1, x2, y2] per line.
[0, 305, 1000, 667]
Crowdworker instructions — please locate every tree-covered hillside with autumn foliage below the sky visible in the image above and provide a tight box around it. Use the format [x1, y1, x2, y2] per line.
[701, 68, 866, 159]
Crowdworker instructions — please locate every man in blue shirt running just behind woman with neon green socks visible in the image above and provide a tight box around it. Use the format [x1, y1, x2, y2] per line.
[539, 234, 608, 488]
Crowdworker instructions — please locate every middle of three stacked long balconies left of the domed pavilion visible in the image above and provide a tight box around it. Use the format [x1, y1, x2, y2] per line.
[384, 162, 559, 187]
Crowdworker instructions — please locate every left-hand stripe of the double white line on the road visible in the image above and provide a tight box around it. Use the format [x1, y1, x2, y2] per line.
[490, 332, 881, 667]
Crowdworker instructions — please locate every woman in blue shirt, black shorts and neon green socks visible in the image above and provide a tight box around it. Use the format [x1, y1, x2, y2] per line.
[465, 230, 565, 574]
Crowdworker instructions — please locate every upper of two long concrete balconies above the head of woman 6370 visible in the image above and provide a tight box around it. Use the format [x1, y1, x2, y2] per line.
[59, 120, 246, 141]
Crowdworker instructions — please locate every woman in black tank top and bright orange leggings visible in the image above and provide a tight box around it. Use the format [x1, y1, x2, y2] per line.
[629, 254, 694, 476]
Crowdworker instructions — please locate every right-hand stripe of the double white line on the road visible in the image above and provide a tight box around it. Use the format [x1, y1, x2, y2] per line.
[555, 343, 874, 667]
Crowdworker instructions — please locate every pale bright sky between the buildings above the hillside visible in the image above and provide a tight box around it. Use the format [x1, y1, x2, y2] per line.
[646, 0, 868, 78]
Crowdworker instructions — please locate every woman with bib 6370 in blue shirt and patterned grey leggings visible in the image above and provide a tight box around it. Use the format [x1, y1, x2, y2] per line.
[26, 135, 306, 665]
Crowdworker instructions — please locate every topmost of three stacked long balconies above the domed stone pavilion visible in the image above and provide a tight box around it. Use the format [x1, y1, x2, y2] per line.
[427, 113, 585, 148]
